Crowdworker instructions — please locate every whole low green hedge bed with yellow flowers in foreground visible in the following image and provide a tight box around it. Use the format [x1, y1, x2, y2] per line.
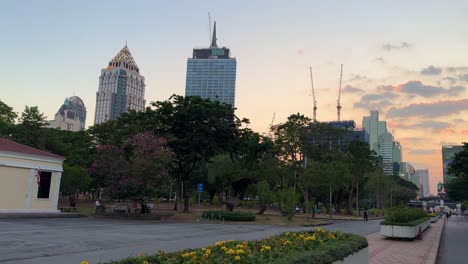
[99, 228, 368, 264]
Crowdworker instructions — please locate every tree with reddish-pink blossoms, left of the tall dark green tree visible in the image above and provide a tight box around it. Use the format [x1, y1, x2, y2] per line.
[93, 132, 173, 213]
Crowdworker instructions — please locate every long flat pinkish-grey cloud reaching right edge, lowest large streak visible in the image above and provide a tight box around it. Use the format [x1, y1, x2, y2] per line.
[387, 99, 468, 118]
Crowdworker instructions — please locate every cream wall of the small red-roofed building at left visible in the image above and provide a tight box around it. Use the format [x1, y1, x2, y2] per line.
[0, 153, 62, 213]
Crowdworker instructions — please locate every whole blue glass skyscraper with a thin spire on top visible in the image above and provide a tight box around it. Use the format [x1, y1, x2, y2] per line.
[185, 22, 237, 107]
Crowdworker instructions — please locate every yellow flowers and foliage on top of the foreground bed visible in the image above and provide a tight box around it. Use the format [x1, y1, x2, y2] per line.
[98, 228, 367, 264]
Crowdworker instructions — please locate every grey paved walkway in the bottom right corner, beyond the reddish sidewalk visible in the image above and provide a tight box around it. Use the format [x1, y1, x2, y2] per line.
[438, 215, 468, 264]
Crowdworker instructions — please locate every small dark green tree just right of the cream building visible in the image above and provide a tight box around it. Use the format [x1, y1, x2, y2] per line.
[60, 164, 92, 207]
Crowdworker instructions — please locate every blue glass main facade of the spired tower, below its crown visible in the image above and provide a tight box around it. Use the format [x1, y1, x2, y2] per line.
[185, 58, 237, 107]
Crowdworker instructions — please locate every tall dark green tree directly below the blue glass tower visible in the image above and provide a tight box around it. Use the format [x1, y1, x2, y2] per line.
[151, 95, 243, 212]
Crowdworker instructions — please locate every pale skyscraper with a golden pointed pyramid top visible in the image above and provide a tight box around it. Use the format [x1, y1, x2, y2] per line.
[94, 44, 146, 124]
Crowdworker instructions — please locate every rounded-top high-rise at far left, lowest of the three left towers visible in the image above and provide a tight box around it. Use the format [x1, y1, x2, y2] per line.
[48, 96, 86, 131]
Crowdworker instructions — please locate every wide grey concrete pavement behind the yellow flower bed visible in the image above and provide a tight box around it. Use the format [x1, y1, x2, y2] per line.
[0, 218, 379, 264]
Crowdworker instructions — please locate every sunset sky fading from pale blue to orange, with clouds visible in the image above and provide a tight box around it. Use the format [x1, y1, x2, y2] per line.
[0, 0, 468, 193]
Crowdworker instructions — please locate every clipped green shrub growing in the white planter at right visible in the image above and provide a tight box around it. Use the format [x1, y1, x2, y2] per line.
[382, 207, 427, 226]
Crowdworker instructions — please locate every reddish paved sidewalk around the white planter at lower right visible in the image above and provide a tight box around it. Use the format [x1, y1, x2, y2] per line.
[367, 219, 445, 264]
